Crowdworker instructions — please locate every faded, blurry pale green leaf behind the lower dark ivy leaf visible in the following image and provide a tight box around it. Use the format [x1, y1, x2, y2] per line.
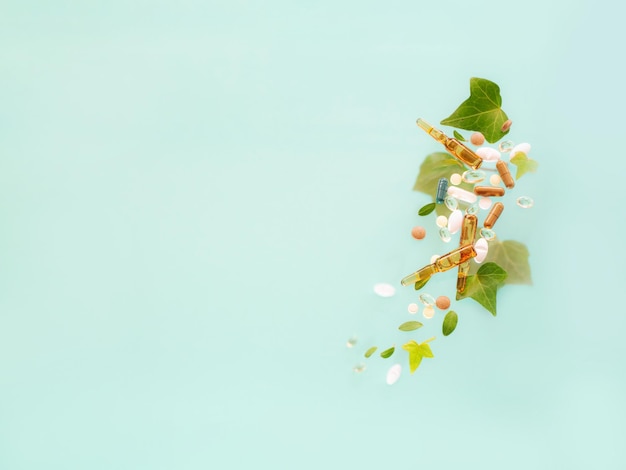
[469, 240, 533, 284]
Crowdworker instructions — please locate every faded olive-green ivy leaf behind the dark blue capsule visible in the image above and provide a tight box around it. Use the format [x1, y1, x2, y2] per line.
[413, 152, 474, 215]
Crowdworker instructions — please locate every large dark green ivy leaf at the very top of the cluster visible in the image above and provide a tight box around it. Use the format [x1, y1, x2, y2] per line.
[441, 77, 509, 143]
